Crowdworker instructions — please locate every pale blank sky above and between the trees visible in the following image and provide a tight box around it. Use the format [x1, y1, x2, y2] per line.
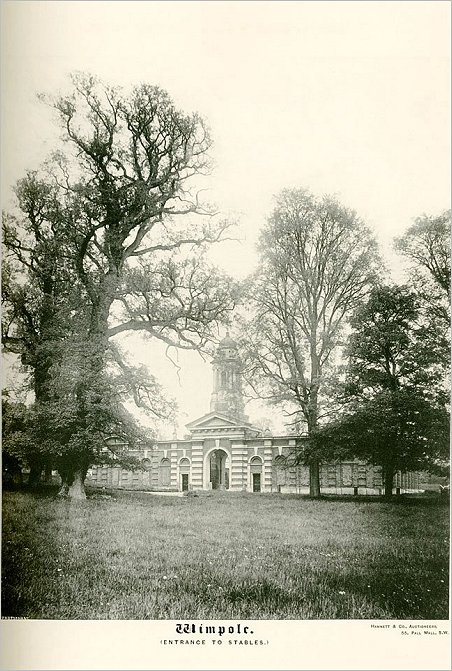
[1, 0, 451, 433]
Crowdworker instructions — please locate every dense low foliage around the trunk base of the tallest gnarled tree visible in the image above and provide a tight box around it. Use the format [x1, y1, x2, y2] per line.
[30, 339, 154, 498]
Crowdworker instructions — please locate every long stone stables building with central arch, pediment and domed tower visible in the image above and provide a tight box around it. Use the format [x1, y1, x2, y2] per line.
[87, 335, 419, 494]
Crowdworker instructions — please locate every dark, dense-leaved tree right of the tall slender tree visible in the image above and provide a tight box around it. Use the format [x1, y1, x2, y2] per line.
[317, 286, 449, 497]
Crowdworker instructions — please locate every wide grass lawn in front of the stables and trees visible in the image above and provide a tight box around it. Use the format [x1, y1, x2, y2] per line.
[2, 492, 449, 620]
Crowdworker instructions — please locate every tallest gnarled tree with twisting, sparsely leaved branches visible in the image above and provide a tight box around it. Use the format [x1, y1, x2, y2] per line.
[5, 75, 234, 496]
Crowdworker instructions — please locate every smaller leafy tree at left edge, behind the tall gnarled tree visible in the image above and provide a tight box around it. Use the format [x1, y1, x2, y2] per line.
[2, 172, 81, 401]
